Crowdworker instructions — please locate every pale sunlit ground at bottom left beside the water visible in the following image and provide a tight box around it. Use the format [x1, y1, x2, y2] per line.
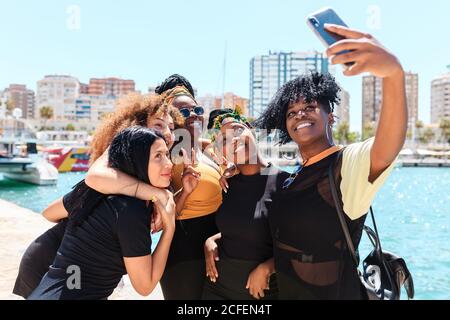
[0, 199, 163, 300]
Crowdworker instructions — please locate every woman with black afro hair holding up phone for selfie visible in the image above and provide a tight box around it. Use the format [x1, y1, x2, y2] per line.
[253, 25, 408, 299]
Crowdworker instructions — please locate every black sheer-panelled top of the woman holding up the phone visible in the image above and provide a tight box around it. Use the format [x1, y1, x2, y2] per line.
[269, 152, 365, 299]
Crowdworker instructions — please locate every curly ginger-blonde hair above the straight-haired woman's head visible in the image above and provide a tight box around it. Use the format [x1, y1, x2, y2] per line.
[90, 93, 184, 163]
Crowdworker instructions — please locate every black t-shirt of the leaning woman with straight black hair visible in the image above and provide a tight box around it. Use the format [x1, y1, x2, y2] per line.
[30, 191, 152, 299]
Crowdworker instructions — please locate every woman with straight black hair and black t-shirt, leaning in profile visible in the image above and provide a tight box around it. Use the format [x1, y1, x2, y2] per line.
[28, 127, 175, 300]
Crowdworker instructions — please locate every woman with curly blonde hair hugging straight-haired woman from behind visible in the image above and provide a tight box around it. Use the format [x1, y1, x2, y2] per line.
[13, 94, 184, 298]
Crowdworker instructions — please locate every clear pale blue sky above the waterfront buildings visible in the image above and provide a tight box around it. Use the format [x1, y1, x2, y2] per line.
[0, 0, 450, 130]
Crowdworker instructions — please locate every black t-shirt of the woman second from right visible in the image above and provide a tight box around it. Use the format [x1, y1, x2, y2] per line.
[216, 168, 282, 262]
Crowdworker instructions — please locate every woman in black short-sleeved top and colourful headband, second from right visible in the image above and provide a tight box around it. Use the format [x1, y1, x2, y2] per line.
[203, 110, 277, 300]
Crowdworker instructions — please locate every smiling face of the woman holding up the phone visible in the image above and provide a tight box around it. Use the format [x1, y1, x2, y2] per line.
[286, 99, 332, 146]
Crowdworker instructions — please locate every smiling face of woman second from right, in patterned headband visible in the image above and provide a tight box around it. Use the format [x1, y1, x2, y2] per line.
[216, 122, 257, 165]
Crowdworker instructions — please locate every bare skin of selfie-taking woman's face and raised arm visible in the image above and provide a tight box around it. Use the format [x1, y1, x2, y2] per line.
[285, 25, 408, 182]
